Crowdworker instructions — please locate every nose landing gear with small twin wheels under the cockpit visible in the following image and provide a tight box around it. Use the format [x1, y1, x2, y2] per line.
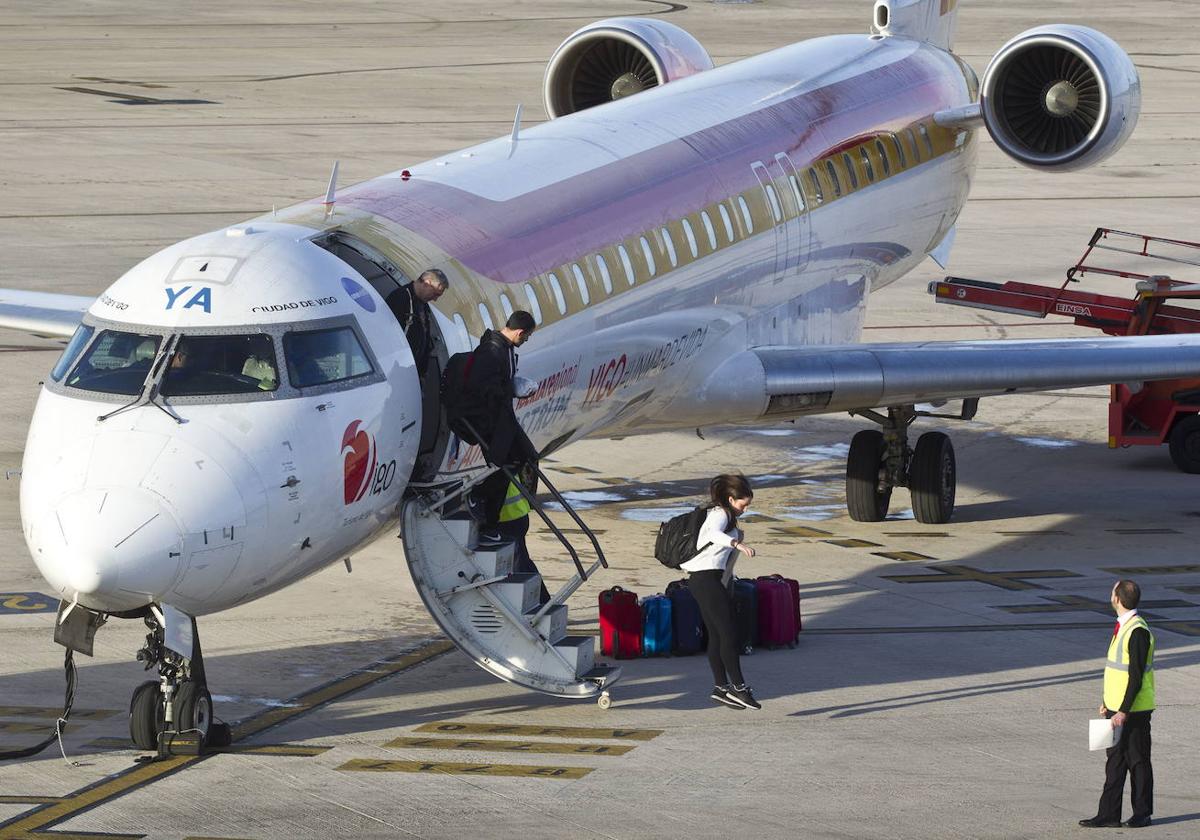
[130, 607, 229, 756]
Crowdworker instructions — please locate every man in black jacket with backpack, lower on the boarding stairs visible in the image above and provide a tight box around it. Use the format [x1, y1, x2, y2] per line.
[464, 310, 538, 535]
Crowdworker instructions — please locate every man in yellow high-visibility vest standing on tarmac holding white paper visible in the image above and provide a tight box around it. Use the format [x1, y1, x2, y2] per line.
[1079, 581, 1154, 828]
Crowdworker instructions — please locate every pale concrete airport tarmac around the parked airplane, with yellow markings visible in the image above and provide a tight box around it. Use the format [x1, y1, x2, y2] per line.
[0, 0, 1200, 840]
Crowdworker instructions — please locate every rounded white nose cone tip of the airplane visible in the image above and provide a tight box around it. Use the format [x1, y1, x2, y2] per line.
[32, 487, 182, 611]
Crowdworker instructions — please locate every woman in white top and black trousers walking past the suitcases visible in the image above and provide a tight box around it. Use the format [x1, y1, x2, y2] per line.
[679, 475, 762, 709]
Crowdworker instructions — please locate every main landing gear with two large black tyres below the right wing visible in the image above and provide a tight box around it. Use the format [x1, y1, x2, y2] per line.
[846, 400, 979, 524]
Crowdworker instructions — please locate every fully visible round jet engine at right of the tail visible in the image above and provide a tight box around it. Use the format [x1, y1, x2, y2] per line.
[979, 25, 1141, 172]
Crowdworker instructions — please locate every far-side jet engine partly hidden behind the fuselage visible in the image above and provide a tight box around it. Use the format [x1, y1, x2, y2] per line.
[542, 18, 713, 119]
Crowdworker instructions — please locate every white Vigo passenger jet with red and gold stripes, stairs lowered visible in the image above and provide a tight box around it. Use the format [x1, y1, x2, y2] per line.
[0, 0, 1200, 750]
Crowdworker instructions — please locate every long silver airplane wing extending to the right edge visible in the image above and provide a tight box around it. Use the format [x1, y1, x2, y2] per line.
[690, 335, 1200, 419]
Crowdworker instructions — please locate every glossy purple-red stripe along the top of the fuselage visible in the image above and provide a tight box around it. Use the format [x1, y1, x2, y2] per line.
[338, 41, 966, 283]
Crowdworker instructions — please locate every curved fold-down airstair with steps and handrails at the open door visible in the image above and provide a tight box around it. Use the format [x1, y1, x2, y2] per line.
[401, 446, 620, 709]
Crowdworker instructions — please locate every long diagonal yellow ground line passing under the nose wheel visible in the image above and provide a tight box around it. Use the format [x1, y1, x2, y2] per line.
[0, 641, 454, 840]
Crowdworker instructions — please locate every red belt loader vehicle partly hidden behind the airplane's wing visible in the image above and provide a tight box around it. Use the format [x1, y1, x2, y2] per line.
[929, 228, 1200, 473]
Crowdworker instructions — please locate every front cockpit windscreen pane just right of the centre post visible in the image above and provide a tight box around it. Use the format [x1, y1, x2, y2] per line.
[162, 335, 280, 397]
